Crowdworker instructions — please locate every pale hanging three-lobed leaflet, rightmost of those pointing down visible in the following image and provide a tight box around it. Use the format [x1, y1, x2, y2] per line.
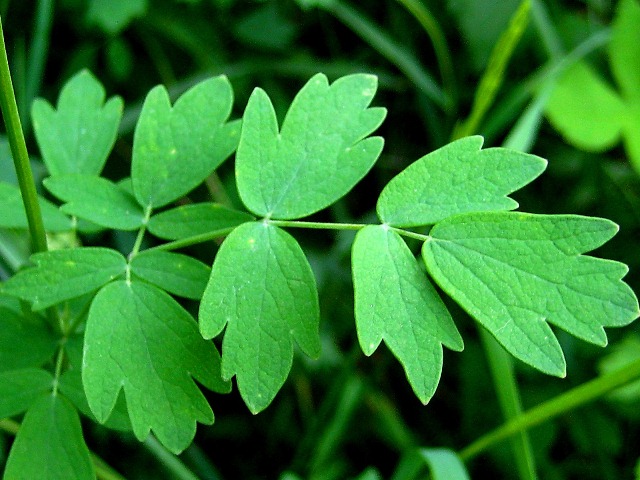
[351, 225, 463, 404]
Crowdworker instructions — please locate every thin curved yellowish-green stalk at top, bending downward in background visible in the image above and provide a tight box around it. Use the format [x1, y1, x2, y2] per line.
[397, 0, 458, 109]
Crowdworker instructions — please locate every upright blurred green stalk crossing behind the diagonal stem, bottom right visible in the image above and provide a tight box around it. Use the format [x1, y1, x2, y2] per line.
[479, 328, 537, 480]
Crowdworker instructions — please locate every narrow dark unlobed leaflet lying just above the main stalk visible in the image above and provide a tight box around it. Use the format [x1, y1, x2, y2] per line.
[148, 203, 254, 240]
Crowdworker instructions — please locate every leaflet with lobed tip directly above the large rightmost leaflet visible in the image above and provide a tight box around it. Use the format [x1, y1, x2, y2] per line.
[377, 136, 547, 227]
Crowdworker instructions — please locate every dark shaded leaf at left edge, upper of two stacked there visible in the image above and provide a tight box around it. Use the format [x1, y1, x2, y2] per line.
[0, 307, 59, 374]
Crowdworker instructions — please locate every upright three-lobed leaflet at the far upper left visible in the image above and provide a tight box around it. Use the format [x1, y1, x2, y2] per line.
[31, 70, 123, 175]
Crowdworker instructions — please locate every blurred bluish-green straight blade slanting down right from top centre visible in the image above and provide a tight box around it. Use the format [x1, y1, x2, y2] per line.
[320, 1, 451, 109]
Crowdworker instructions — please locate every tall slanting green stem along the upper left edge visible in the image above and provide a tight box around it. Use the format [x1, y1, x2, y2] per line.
[0, 15, 47, 252]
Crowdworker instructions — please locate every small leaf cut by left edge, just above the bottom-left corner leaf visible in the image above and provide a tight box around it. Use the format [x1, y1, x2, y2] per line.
[0, 368, 53, 418]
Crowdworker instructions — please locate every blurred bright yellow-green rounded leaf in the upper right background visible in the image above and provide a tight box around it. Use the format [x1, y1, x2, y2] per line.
[546, 62, 626, 152]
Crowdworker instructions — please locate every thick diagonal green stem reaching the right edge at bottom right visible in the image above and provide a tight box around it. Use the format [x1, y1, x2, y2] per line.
[459, 360, 640, 462]
